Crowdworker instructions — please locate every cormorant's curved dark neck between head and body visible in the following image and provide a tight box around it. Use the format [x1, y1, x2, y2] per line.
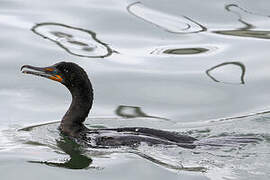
[60, 83, 93, 136]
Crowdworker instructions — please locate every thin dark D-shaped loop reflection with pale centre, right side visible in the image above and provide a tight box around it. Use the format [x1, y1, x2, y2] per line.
[206, 62, 246, 84]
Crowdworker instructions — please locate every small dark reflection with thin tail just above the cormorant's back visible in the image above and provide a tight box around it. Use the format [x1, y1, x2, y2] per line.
[115, 105, 169, 121]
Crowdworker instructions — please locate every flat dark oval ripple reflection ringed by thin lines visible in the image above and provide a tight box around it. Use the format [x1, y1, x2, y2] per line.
[150, 47, 209, 55]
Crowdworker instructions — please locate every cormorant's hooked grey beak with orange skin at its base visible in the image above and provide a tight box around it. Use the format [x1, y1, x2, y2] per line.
[21, 65, 63, 83]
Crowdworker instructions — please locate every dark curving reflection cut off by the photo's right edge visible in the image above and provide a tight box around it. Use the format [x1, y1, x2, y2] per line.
[214, 4, 270, 39]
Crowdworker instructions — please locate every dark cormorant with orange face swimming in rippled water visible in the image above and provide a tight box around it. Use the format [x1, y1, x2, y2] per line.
[21, 62, 197, 148]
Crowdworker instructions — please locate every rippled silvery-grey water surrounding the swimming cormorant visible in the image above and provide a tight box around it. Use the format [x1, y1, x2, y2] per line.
[0, 0, 270, 180]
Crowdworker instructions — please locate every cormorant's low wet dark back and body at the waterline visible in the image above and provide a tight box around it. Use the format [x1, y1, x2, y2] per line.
[78, 127, 196, 149]
